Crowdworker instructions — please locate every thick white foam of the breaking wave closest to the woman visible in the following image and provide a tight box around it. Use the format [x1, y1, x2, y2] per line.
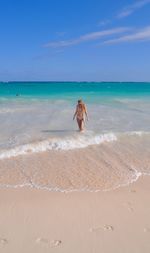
[0, 133, 117, 160]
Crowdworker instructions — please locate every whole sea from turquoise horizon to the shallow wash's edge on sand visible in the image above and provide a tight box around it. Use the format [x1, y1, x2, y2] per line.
[0, 82, 150, 192]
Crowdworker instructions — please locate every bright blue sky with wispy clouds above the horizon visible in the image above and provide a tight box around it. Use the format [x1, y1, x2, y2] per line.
[0, 0, 150, 81]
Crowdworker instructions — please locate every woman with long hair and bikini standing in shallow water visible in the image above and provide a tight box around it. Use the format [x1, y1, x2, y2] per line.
[73, 100, 88, 131]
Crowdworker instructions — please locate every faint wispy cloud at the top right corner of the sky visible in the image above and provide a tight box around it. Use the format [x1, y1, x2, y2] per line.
[116, 0, 150, 18]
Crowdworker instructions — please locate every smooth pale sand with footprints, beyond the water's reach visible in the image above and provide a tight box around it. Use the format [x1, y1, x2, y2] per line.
[0, 176, 150, 253]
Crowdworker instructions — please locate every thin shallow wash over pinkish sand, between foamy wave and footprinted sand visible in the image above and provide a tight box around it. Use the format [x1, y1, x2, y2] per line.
[0, 135, 150, 192]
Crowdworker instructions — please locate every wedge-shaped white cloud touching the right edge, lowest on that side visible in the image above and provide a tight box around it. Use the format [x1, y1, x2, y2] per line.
[103, 26, 150, 44]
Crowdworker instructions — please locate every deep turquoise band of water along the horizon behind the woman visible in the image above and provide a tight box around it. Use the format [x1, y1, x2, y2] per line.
[0, 82, 150, 100]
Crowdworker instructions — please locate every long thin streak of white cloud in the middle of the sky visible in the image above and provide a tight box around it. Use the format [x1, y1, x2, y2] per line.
[44, 27, 129, 48]
